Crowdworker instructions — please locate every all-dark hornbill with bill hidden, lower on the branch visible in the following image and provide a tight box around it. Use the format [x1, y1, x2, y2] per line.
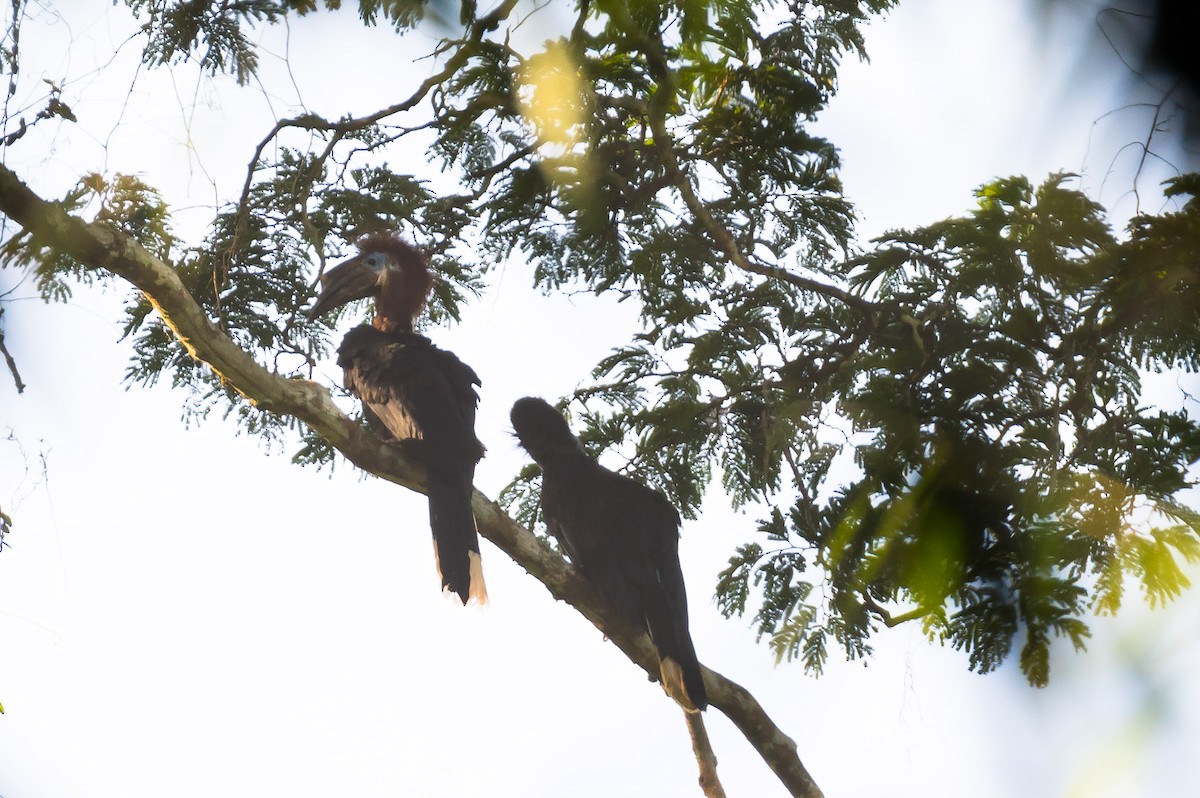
[511, 397, 708, 712]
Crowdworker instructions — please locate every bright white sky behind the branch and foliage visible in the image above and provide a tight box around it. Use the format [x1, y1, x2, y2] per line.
[0, 0, 1200, 798]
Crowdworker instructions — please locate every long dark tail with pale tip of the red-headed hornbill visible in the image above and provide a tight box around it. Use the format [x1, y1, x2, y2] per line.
[428, 470, 487, 604]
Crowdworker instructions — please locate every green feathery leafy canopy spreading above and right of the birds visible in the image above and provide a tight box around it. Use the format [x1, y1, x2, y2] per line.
[7, 0, 1200, 684]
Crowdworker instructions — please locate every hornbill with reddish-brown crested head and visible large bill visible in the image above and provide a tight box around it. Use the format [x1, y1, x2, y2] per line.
[308, 233, 487, 604]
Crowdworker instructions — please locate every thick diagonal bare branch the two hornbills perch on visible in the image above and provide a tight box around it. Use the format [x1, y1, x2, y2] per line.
[0, 166, 821, 798]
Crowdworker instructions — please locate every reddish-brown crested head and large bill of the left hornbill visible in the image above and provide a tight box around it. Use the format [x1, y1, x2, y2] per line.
[308, 233, 433, 330]
